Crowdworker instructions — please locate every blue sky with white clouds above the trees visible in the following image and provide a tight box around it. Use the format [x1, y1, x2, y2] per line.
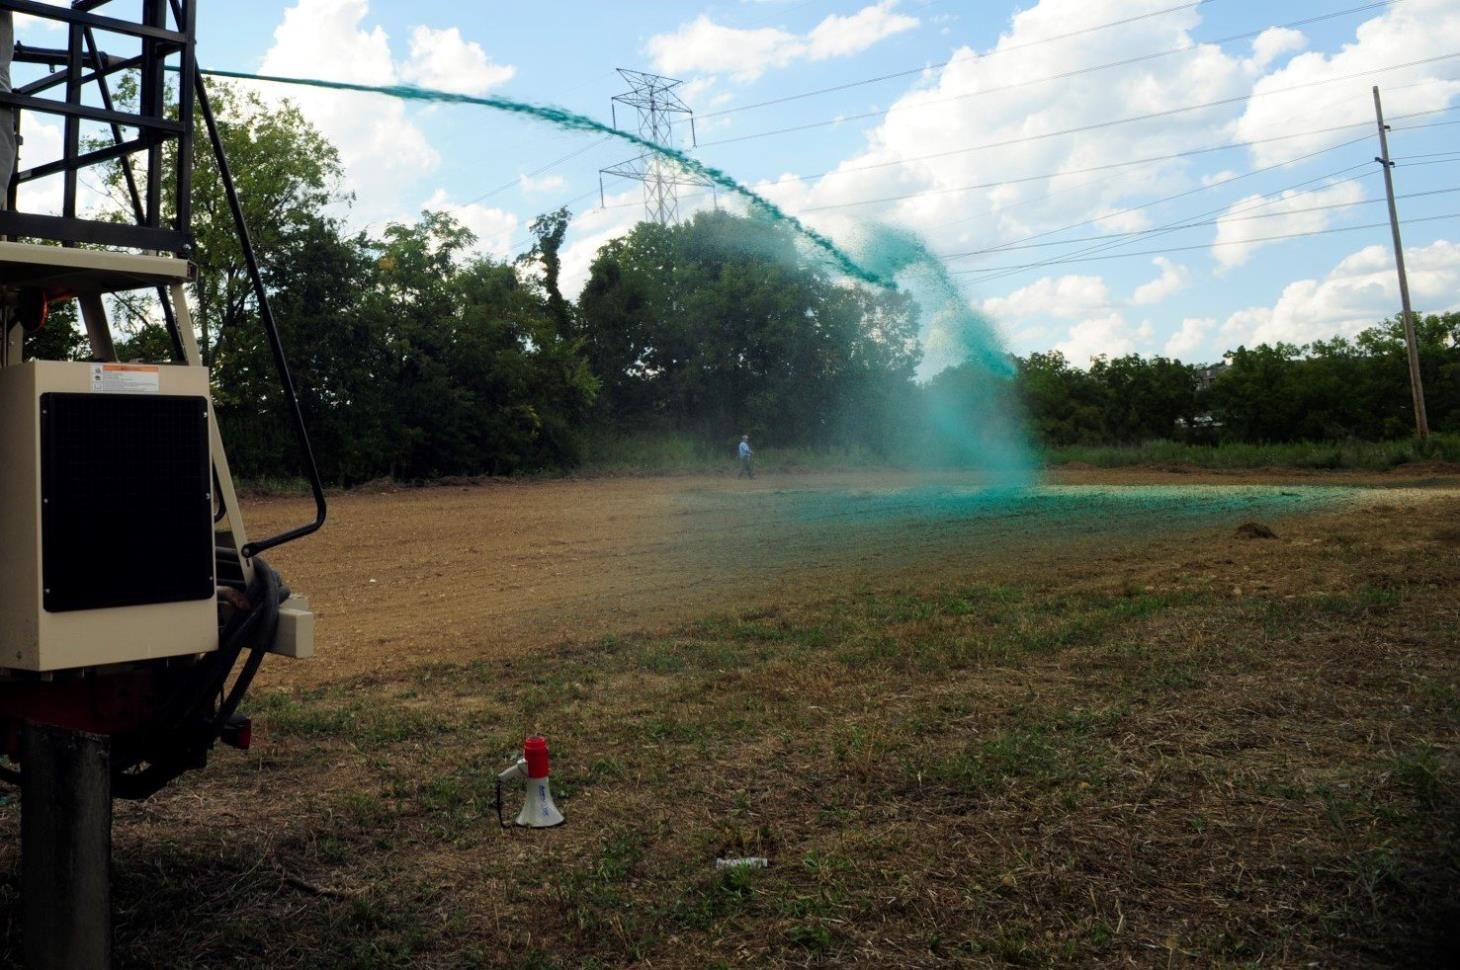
[11, 0, 1460, 365]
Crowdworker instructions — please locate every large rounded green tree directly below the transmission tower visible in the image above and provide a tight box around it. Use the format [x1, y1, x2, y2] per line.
[578, 212, 918, 444]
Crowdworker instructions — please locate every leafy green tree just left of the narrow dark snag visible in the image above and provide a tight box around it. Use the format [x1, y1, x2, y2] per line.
[359, 213, 596, 478]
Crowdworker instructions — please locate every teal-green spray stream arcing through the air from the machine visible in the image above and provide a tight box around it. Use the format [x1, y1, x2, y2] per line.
[201, 70, 1032, 488]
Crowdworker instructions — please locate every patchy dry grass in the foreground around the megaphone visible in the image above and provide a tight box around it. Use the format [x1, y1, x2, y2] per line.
[0, 501, 1460, 969]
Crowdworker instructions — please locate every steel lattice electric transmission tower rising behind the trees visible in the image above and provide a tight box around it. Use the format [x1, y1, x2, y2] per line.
[599, 67, 715, 225]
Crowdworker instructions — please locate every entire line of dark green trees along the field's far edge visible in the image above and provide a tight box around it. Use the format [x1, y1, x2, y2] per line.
[32, 89, 1460, 485]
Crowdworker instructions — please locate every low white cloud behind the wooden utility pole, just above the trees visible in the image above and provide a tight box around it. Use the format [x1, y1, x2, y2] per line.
[1222, 240, 1460, 348]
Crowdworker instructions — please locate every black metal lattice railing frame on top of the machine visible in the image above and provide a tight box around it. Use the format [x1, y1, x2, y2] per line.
[0, 0, 197, 257]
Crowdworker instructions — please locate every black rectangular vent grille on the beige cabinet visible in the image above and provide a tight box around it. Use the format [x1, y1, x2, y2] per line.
[41, 393, 215, 612]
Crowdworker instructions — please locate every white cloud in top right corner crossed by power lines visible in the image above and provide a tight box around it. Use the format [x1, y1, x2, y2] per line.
[1235, 0, 1460, 165]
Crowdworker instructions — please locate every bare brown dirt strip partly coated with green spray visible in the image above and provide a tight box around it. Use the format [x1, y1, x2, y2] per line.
[245, 469, 1460, 684]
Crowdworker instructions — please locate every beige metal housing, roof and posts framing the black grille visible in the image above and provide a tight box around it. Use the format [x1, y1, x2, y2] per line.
[0, 241, 314, 678]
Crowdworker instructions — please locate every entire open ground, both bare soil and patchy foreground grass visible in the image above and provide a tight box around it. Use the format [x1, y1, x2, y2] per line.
[0, 469, 1460, 970]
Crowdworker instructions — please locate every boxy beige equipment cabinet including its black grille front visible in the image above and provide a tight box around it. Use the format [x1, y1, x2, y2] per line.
[0, 361, 218, 672]
